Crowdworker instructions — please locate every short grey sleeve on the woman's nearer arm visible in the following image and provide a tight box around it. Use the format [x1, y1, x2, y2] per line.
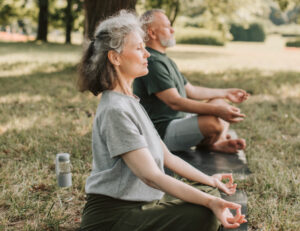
[100, 109, 147, 157]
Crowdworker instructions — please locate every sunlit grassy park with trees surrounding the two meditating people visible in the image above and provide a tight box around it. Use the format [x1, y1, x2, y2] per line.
[0, 0, 300, 231]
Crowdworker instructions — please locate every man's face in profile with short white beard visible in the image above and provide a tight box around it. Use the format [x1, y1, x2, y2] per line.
[152, 12, 176, 47]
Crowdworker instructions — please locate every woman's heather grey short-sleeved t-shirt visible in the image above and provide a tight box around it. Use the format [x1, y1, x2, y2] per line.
[85, 91, 164, 201]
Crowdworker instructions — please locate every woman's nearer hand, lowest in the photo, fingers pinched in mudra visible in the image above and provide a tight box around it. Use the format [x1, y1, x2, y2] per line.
[208, 197, 247, 229]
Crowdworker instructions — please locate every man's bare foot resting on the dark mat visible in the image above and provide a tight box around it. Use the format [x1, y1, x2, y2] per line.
[210, 139, 246, 153]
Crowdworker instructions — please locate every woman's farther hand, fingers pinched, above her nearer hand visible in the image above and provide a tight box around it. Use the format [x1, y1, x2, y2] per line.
[211, 173, 237, 195]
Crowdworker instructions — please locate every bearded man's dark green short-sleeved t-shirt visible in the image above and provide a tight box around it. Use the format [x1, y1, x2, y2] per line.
[133, 47, 187, 139]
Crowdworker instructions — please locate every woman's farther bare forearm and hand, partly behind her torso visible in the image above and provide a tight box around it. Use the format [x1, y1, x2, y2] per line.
[161, 141, 237, 195]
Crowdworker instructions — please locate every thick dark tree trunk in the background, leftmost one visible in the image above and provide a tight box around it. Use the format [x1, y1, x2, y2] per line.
[36, 0, 48, 42]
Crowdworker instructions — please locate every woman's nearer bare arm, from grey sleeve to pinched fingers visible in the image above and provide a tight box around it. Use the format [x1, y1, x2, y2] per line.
[122, 148, 246, 228]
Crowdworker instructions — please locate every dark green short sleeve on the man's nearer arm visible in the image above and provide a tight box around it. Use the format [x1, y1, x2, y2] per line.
[142, 61, 175, 95]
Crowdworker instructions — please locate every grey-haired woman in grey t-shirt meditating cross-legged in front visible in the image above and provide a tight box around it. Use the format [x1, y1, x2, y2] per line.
[79, 11, 246, 231]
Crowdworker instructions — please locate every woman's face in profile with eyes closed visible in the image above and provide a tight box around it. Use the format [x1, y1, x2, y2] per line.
[119, 32, 150, 79]
